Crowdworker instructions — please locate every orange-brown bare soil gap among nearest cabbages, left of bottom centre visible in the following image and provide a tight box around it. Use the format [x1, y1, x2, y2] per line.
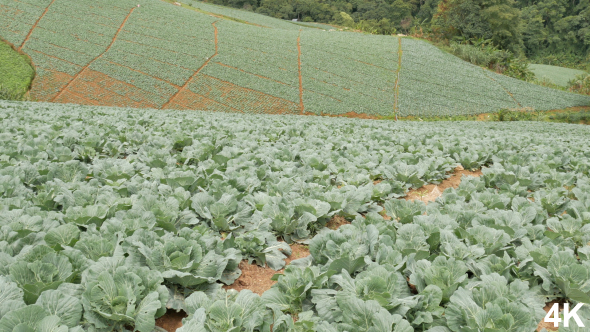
[223, 243, 309, 295]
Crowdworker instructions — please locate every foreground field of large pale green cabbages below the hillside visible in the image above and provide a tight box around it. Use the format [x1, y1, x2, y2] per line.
[0, 102, 590, 332]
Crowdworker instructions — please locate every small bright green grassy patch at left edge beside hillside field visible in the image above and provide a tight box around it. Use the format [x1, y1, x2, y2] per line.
[0, 40, 35, 100]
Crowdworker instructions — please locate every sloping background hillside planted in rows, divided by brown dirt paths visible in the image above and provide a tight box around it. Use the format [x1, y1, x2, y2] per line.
[0, 0, 590, 116]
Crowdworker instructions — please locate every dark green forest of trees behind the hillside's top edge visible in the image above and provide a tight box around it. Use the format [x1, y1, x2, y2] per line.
[208, 0, 590, 69]
